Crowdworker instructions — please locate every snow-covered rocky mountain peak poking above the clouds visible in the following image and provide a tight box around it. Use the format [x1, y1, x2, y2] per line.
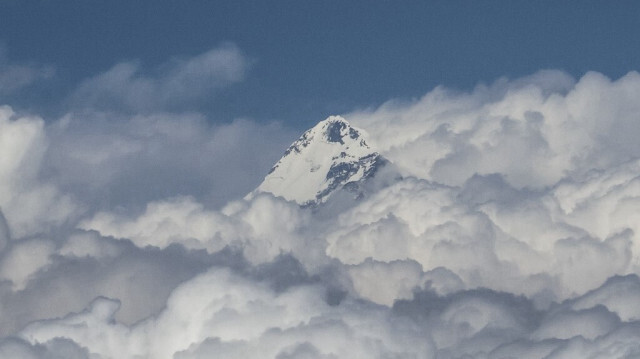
[254, 116, 387, 205]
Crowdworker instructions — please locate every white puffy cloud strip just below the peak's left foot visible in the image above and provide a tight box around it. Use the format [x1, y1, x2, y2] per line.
[79, 195, 317, 264]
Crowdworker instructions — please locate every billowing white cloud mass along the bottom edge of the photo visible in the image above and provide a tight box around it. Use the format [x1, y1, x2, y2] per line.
[20, 269, 640, 358]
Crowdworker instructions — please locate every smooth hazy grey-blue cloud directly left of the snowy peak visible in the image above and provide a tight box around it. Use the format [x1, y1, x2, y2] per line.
[42, 113, 295, 210]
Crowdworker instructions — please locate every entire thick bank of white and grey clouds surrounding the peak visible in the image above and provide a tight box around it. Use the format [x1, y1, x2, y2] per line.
[0, 69, 640, 359]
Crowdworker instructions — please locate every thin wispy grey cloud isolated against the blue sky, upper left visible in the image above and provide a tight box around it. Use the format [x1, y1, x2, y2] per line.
[69, 44, 250, 112]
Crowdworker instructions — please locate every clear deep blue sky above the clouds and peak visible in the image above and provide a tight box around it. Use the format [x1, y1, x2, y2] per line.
[0, 0, 640, 129]
